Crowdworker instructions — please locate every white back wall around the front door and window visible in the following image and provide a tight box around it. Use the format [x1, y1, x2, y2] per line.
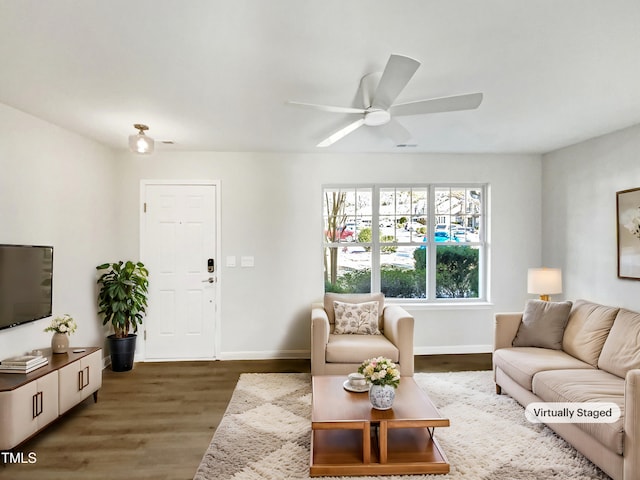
[120, 152, 541, 359]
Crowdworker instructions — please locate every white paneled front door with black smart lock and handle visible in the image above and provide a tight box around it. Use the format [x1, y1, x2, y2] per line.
[141, 183, 218, 360]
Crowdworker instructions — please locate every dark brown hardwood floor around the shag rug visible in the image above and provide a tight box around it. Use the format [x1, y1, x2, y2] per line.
[0, 354, 491, 480]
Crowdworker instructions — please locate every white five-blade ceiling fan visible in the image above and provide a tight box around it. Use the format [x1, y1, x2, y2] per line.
[287, 55, 482, 147]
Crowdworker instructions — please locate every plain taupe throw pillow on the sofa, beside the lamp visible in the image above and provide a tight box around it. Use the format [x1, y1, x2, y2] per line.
[513, 300, 571, 350]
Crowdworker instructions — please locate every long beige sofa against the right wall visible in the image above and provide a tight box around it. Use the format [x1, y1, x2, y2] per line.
[493, 300, 640, 480]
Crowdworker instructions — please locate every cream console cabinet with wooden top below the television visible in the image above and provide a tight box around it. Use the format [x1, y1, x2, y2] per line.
[0, 347, 102, 450]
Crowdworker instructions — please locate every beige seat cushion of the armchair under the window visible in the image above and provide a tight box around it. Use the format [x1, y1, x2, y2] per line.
[326, 334, 400, 364]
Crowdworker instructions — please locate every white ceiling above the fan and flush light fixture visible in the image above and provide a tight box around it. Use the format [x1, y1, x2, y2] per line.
[0, 0, 640, 153]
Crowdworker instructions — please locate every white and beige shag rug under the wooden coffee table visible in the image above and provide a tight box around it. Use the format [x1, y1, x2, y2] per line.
[194, 371, 609, 480]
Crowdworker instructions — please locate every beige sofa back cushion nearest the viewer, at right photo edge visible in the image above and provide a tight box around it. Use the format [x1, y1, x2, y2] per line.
[598, 308, 640, 378]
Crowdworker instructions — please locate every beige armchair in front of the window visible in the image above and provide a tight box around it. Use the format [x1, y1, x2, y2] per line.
[311, 293, 413, 377]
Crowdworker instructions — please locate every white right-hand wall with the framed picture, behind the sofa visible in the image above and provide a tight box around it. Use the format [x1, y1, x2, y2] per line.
[542, 125, 640, 310]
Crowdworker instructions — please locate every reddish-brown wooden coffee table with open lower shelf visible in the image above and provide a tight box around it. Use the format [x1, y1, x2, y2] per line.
[309, 375, 449, 477]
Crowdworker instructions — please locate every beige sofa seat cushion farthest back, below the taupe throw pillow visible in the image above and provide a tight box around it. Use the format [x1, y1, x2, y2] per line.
[493, 347, 594, 391]
